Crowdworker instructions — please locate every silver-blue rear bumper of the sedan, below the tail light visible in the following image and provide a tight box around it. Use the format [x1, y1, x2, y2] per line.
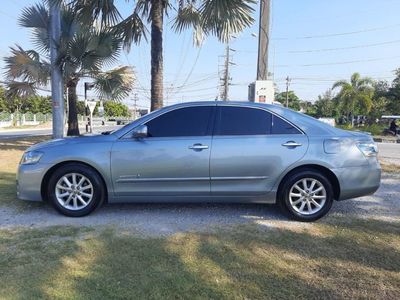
[332, 163, 381, 200]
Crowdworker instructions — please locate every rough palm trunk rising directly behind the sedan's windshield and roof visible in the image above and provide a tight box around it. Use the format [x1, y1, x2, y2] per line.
[150, 0, 164, 111]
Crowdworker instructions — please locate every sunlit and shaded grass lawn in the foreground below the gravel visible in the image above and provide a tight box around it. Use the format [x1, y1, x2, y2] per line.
[0, 219, 400, 299]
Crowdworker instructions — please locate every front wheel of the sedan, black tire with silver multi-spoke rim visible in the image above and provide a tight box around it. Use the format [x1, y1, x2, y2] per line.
[47, 163, 105, 217]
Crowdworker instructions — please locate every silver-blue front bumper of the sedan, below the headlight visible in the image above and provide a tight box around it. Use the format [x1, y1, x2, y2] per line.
[17, 163, 50, 201]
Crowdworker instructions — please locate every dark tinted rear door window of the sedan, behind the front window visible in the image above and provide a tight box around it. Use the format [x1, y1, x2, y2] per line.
[215, 106, 271, 135]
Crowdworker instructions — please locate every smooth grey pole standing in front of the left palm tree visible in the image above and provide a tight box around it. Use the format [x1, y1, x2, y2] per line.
[50, 1, 64, 139]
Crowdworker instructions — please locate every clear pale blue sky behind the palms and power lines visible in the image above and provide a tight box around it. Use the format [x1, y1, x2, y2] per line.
[0, 0, 400, 107]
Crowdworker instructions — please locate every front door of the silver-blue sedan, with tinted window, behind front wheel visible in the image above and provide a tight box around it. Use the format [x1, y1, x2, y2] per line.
[111, 105, 215, 196]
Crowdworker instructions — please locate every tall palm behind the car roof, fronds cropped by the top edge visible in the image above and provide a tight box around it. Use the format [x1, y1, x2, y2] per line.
[68, 0, 257, 110]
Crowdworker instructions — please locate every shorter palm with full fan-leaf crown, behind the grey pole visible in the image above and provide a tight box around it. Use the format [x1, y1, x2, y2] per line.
[5, 4, 134, 135]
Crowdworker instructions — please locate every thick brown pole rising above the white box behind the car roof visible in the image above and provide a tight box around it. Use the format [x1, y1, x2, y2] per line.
[257, 0, 271, 80]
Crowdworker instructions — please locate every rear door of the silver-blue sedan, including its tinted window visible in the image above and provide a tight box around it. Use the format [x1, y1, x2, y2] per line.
[210, 105, 308, 196]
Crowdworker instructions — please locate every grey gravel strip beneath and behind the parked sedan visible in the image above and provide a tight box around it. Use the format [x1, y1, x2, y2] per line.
[0, 174, 400, 236]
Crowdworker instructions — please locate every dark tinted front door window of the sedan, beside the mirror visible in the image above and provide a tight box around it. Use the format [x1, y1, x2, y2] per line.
[146, 106, 213, 137]
